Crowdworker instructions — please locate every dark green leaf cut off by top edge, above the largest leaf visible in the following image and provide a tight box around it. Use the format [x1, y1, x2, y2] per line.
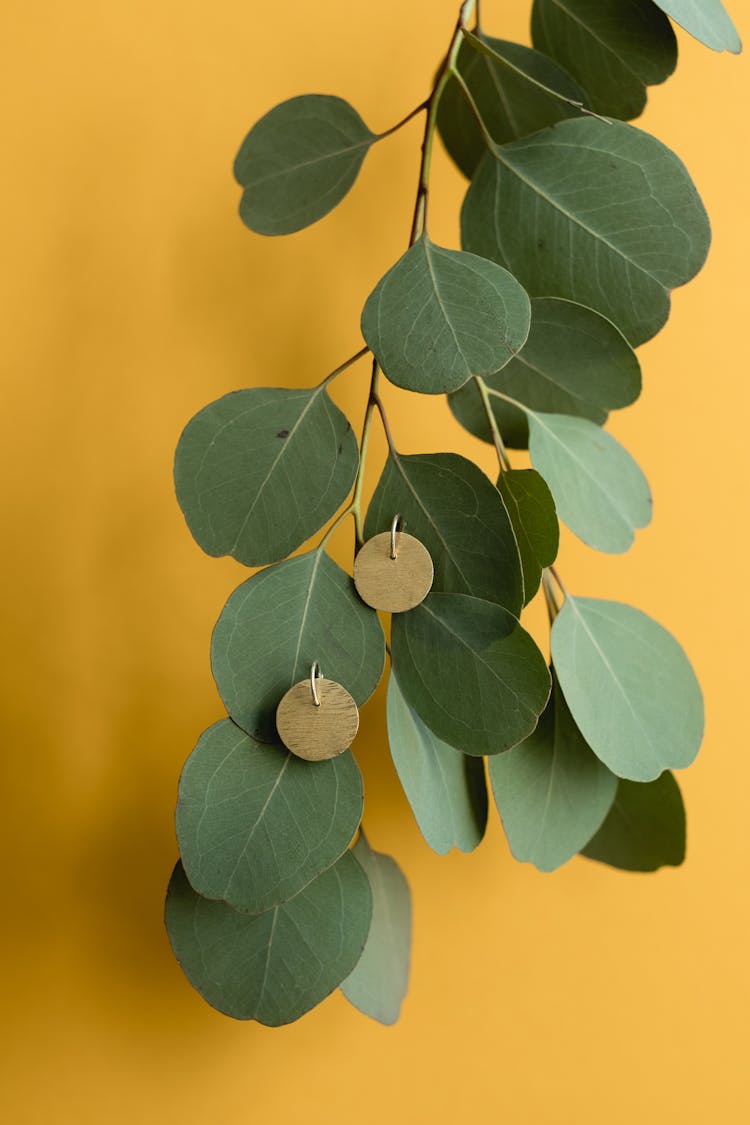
[531, 0, 677, 119]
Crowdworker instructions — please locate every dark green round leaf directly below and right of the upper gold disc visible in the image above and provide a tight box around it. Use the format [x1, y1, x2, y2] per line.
[391, 594, 550, 755]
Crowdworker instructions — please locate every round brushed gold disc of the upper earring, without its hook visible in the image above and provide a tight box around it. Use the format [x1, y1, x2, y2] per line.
[354, 531, 434, 613]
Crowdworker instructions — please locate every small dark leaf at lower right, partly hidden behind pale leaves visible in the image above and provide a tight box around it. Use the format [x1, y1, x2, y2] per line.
[581, 771, 686, 871]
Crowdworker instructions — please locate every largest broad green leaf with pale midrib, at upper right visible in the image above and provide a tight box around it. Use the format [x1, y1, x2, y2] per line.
[461, 119, 711, 345]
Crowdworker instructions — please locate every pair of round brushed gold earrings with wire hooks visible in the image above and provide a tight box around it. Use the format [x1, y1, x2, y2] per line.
[275, 515, 433, 762]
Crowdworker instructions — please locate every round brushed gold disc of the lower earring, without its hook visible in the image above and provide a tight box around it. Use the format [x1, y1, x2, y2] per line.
[275, 676, 360, 762]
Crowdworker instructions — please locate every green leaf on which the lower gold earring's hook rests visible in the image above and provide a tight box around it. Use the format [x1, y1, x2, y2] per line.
[211, 549, 386, 741]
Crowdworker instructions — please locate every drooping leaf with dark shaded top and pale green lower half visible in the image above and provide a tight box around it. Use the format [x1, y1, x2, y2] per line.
[489, 686, 617, 871]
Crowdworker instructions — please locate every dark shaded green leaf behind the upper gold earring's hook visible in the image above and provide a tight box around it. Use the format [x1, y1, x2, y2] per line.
[364, 450, 523, 617]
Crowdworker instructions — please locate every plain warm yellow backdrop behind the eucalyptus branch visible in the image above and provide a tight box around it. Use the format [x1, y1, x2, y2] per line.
[0, 0, 750, 1125]
